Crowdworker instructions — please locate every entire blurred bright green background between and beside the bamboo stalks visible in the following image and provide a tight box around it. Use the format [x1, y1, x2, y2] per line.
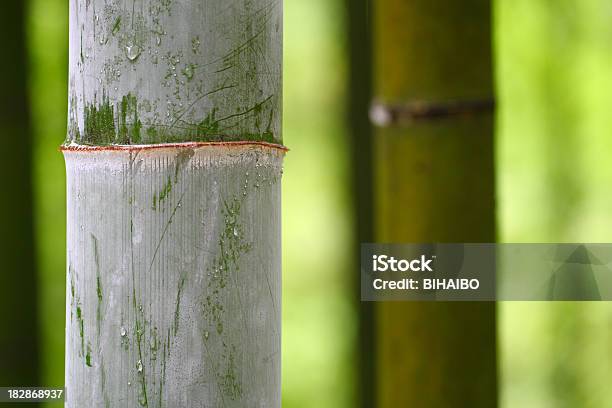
[28, 0, 612, 408]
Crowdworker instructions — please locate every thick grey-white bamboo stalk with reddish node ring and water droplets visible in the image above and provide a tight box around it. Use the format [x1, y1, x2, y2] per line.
[63, 0, 285, 407]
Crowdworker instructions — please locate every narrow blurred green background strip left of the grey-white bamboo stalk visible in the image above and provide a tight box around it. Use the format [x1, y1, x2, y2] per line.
[28, 0, 68, 396]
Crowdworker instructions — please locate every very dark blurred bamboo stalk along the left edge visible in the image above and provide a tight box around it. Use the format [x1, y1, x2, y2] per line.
[0, 1, 39, 386]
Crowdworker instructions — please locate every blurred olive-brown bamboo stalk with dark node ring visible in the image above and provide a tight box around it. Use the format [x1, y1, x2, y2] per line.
[373, 0, 497, 407]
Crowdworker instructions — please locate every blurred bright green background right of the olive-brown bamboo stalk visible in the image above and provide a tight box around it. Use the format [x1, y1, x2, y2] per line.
[494, 0, 612, 408]
